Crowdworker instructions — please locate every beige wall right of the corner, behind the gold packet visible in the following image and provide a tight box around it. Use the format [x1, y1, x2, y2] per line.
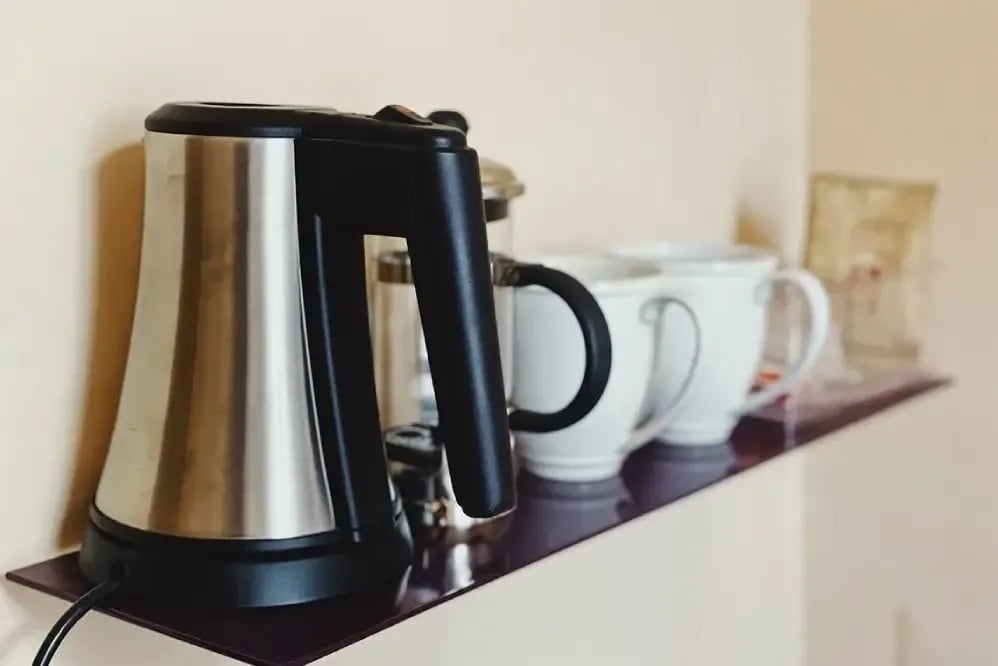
[805, 0, 998, 666]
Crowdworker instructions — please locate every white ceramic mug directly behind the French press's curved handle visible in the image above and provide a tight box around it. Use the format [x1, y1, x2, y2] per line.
[512, 254, 697, 481]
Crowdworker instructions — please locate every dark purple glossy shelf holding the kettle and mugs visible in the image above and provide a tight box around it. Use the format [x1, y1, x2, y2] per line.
[7, 378, 949, 666]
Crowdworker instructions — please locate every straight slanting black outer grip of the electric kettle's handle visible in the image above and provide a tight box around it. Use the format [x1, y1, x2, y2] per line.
[406, 149, 516, 518]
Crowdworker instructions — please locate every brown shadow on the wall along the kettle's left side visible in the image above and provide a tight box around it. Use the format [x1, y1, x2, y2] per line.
[59, 143, 145, 548]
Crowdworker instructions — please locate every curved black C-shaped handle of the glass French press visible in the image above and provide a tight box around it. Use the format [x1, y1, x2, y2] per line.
[506, 264, 613, 432]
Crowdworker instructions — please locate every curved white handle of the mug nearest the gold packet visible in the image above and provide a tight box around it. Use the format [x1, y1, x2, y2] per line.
[737, 268, 830, 414]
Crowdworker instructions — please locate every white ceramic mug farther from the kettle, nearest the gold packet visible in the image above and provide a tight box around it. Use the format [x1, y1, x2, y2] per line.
[614, 243, 829, 445]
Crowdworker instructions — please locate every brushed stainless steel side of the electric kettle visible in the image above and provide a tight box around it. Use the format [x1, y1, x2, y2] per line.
[95, 132, 335, 539]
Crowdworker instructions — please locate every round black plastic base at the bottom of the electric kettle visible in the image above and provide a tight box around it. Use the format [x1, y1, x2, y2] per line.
[80, 507, 412, 608]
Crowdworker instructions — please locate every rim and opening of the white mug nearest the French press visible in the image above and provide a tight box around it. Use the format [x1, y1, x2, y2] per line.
[518, 252, 663, 296]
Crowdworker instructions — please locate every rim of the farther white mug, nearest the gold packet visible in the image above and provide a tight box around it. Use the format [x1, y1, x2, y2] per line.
[612, 241, 779, 273]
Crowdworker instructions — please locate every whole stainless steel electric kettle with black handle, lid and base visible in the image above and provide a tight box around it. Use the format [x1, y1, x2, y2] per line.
[80, 103, 515, 607]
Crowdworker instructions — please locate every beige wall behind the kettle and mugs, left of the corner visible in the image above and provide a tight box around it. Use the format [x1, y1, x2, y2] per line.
[0, 0, 806, 664]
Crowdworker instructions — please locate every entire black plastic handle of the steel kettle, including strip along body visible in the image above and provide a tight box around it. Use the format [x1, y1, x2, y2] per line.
[295, 130, 516, 528]
